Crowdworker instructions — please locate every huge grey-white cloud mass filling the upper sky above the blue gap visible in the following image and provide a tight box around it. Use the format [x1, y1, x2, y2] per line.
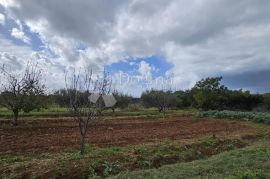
[2, 0, 270, 92]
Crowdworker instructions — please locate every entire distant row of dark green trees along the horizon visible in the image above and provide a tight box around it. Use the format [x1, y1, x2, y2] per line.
[0, 77, 270, 117]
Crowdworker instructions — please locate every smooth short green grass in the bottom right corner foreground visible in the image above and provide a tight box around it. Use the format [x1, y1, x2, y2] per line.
[113, 143, 270, 179]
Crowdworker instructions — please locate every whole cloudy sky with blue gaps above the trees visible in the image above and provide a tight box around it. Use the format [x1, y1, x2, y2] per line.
[0, 0, 270, 96]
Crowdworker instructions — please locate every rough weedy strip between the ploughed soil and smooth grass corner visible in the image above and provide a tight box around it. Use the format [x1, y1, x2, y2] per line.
[0, 137, 247, 178]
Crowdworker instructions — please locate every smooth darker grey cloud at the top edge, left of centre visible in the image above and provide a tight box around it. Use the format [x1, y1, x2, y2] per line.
[5, 0, 130, 44]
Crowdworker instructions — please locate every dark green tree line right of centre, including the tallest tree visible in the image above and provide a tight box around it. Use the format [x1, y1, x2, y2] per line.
[141, 77, 270, 111]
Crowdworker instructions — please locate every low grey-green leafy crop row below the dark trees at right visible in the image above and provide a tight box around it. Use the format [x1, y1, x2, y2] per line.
[196, 110, 270, 124]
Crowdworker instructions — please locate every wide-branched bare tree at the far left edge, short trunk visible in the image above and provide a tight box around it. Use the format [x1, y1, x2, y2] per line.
[0, 62, 45, 125]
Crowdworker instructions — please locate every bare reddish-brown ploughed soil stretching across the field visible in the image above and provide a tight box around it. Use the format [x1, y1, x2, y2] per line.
[0, 117, 253, 154]
